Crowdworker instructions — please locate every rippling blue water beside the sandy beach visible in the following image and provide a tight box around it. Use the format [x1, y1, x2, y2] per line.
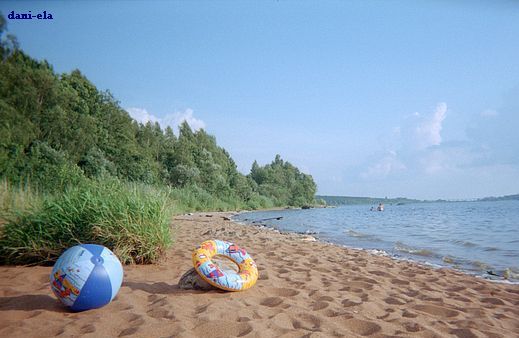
[234, 201, 519, 282]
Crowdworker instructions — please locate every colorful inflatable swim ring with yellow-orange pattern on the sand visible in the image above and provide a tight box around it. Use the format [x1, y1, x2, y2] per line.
[193, 239, 258, 291]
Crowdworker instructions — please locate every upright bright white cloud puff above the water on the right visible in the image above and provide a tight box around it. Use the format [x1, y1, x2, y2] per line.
[415, 102, 447, 149]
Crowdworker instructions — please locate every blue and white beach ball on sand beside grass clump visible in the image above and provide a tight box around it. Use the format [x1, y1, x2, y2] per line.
[50, 244, 123, 311]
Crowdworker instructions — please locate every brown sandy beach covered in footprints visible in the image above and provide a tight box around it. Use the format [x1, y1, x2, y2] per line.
[0, 213, 519, 337]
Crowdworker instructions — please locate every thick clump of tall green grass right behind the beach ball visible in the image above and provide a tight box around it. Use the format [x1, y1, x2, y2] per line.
[0, 180, 171, 264]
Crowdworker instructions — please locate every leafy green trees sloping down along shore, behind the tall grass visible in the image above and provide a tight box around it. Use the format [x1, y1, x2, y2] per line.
[0, 16, 316, 208]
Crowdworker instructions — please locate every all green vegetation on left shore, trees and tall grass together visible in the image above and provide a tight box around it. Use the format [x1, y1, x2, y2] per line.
[0, 15, 316, 263]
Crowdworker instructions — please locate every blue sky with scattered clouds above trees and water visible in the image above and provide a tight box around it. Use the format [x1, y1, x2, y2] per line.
[4, 0, 519, 199]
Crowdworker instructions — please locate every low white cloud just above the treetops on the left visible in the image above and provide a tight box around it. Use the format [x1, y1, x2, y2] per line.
[126, 107, 205, 131]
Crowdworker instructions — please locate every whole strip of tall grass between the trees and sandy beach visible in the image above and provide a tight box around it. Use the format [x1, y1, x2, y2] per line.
[0, 178, 278, 264]
